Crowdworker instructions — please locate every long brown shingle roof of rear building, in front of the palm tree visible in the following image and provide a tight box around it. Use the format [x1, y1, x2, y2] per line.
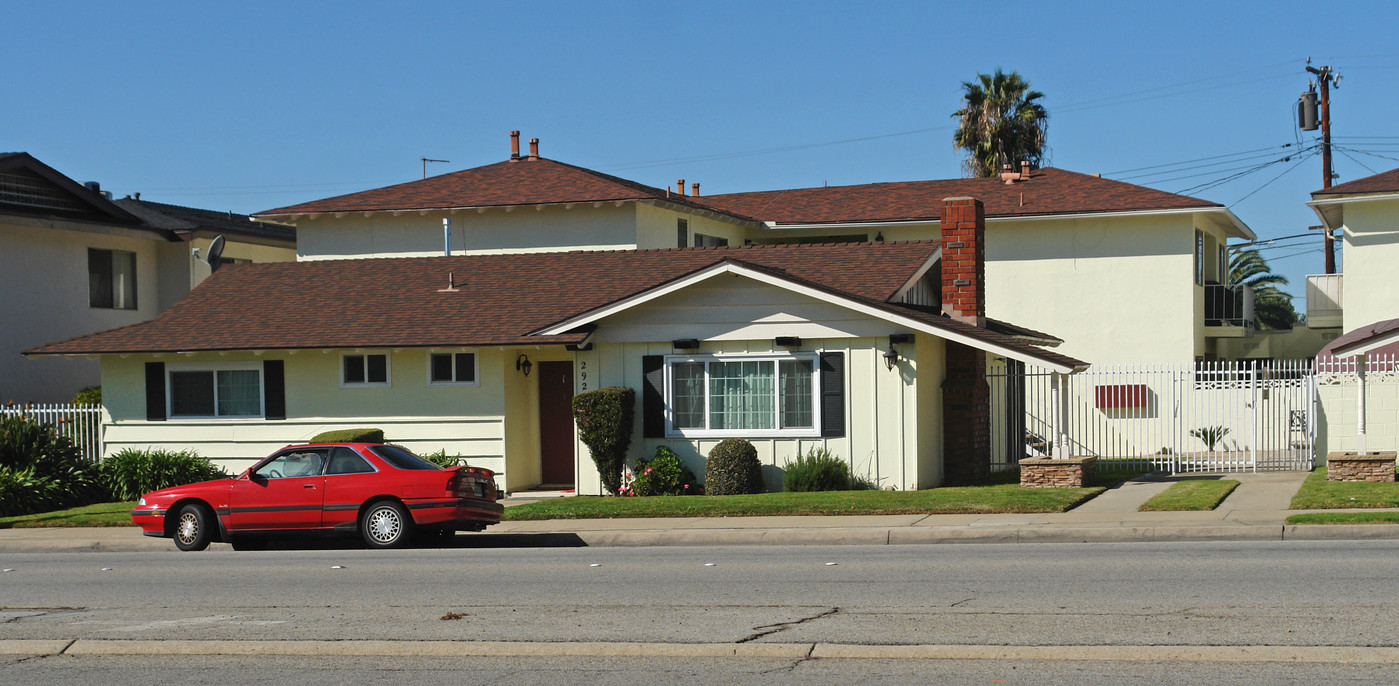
[695, 167, 1221, 224]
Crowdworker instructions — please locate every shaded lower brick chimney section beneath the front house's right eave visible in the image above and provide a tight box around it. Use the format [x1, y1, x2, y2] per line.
[943, 340, 990, 486]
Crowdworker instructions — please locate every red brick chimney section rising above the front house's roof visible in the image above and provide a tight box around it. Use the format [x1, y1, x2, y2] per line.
[942, 197, 986, 326]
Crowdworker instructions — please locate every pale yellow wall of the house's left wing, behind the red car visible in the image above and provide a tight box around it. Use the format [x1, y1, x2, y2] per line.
[102, 349, 513, 483]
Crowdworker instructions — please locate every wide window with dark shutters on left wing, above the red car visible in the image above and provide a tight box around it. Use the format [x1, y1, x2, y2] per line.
[166, 363, 263, 419]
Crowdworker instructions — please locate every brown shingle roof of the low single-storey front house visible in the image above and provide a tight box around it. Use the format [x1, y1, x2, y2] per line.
[27, 241, 1074, 365]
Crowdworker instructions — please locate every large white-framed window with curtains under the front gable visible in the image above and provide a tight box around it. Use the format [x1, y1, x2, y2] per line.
[666, 354, 820, 437]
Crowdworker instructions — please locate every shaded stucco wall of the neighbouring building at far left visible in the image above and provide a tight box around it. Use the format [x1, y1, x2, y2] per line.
[0, 224, 162, 402]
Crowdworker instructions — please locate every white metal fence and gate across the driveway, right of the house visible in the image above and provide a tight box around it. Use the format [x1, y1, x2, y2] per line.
[986, 360, 1316, 473]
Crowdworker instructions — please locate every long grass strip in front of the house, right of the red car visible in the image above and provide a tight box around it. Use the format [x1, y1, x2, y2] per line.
[504, 483, 1105, 521]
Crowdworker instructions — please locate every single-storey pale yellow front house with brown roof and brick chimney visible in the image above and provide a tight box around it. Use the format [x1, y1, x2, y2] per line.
[28, 201, 1086, 493]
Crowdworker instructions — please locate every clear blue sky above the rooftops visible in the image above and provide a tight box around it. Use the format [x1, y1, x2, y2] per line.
[10, 1, 1399, 305]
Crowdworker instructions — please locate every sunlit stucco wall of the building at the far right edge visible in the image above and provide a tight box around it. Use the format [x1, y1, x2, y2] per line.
[1342, 200, 1399, 332]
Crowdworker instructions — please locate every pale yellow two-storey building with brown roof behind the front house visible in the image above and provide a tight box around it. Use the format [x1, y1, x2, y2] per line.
[260, 136, 1254, 363]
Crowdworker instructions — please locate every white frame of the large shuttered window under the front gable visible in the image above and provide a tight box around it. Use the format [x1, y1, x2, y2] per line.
[665, 351, 821, 438]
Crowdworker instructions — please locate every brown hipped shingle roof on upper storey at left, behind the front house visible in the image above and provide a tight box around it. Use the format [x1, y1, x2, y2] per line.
[257, 157, 727, 216]
